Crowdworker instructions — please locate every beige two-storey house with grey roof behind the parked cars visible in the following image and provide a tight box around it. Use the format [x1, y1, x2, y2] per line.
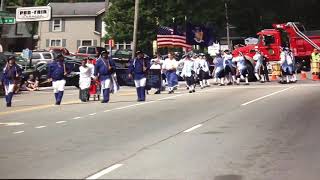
[37, 2, 105, 52]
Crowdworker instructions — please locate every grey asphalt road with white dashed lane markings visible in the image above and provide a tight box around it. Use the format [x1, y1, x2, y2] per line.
[0, 81, 320, 180]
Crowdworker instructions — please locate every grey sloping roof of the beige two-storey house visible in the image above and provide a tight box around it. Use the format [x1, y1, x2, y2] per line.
[48, 2, 105, 17]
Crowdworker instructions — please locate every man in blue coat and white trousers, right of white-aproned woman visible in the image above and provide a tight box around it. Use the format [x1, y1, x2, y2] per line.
[94, 51, 116, 103]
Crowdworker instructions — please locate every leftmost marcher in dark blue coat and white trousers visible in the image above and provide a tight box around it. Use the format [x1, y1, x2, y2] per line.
[1, 56, 22, 107]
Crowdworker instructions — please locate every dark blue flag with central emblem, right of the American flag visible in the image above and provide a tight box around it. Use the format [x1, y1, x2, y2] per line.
[186, 23, 215, 46]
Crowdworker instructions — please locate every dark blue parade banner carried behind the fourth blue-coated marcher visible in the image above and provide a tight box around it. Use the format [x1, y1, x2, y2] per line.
[116, 68, 162, 89]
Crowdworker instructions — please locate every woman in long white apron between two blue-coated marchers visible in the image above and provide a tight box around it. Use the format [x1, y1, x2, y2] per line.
[79, 59, 93, 102]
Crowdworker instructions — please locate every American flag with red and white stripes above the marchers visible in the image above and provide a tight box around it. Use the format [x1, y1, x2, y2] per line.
[157, 26, 192, 48]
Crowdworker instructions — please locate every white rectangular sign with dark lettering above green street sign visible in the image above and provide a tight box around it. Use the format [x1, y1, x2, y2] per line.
[16, 6, 51, 22]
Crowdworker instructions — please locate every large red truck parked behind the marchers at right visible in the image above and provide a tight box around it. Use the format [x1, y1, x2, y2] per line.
[233, 22, 320, 69]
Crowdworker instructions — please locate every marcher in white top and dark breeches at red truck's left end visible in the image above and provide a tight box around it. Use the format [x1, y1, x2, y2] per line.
[223, 50, 236, 85]
